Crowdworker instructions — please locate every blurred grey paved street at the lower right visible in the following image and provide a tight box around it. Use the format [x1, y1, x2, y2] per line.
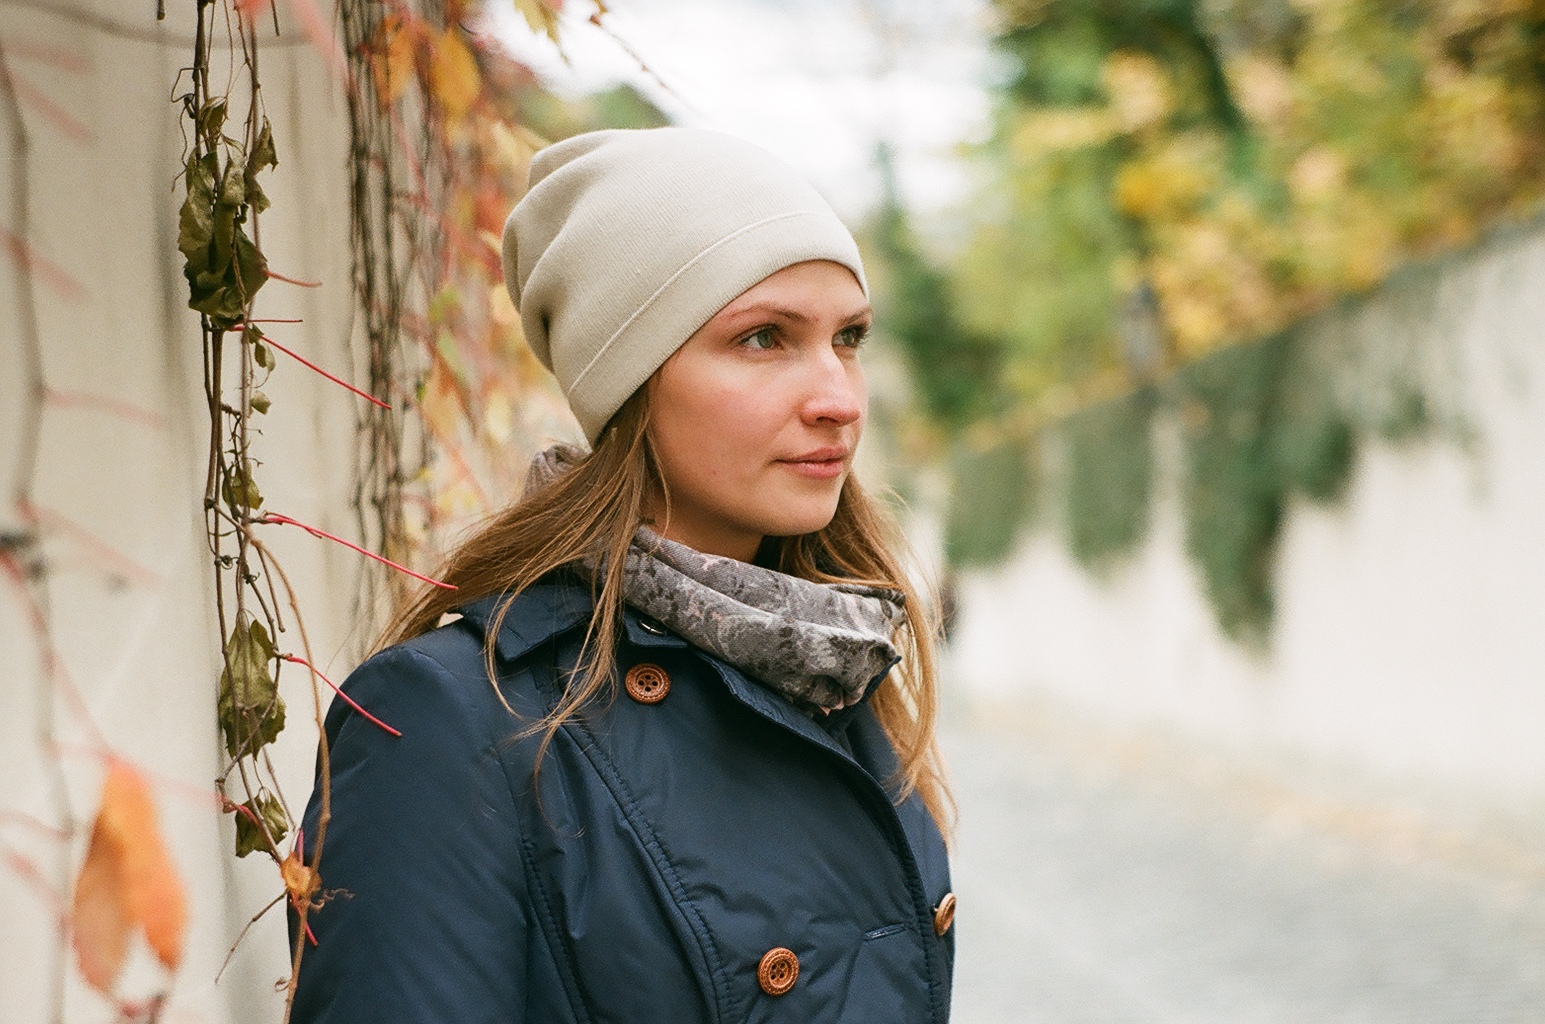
[946, 715, 1545, 1024]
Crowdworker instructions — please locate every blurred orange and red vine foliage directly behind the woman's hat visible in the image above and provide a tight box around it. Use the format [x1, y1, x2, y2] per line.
[338, 0, 611, 615]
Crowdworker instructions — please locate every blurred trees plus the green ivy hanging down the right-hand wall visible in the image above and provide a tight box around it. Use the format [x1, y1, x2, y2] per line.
[881, 0, 1545, 643]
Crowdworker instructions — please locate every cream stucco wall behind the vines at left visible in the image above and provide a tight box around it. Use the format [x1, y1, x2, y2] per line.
[0, 0, 360, 1022]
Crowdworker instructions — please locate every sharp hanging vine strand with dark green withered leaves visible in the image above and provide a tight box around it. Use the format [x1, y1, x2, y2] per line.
[178, 0, 342, 1007]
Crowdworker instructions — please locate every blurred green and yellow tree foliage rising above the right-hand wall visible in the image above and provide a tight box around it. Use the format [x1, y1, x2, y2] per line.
[952, 0, 1545, 402]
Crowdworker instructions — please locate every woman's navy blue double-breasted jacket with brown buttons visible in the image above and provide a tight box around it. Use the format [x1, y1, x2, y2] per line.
[292, 581, 955, 1024]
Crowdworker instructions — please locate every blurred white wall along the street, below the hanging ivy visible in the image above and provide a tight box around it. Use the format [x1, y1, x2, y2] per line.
[950, 221, 1545, 805]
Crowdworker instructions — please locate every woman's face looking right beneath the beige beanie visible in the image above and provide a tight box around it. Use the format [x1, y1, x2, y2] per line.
[647, 261, 870, 561]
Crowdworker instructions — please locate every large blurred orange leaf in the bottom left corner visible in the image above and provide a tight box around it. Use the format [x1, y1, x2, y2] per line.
[73, 761, 187, 993]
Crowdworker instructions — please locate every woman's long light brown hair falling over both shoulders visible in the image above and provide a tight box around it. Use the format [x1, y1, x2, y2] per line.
[382, 388, 955, 834]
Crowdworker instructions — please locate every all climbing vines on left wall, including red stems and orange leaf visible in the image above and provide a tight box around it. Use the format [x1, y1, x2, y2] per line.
[0, 0, 645, 1021]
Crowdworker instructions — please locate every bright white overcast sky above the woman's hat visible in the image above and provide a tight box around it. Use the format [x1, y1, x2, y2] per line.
[487, 0, 992, 219]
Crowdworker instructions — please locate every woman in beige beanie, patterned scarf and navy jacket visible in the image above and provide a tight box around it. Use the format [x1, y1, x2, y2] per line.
[294, 128, 955, 1024]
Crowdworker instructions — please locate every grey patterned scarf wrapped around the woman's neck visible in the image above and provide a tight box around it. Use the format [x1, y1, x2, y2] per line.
[528, 446, 905, 710]
